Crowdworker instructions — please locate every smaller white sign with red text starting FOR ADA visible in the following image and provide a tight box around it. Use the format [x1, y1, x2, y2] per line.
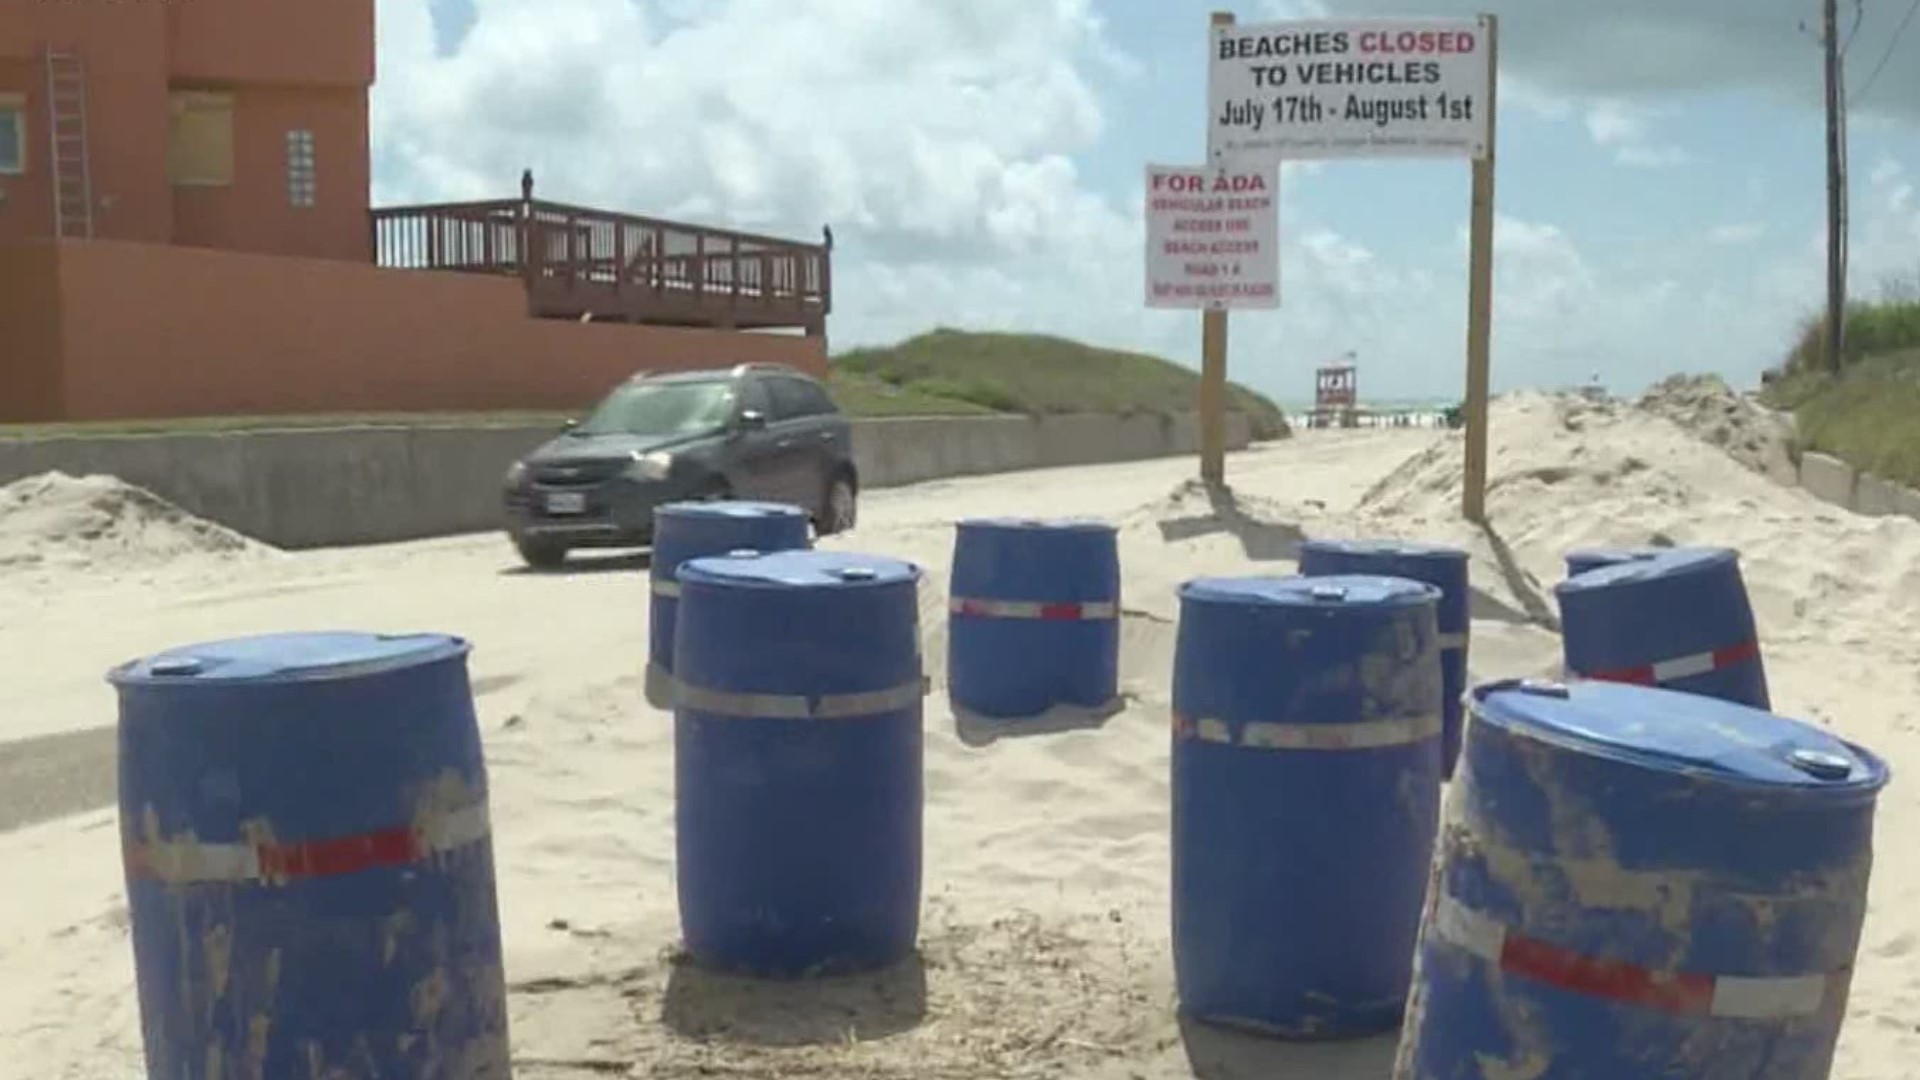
[1146, 161, 1281, 309]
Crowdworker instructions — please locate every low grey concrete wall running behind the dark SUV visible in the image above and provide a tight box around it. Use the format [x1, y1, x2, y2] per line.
[0, 415, 1248, 548]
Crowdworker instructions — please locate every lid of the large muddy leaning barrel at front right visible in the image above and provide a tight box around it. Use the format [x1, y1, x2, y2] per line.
[1473, 680, 1887, 794]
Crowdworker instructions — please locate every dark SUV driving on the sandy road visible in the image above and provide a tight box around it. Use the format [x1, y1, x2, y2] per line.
[505, 363, 860, 567]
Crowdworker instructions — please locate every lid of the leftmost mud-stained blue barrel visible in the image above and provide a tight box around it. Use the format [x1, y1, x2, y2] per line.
[108, 630, 470, 686]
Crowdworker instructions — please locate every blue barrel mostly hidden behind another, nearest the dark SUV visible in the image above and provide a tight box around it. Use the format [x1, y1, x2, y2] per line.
[647, 502, 812, 709]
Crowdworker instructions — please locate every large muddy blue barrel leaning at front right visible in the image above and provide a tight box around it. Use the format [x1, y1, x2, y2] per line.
[1394, 682, 1887, 1080]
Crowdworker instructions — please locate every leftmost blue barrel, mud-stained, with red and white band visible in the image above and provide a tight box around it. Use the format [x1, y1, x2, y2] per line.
[108, 632, 509, 1080]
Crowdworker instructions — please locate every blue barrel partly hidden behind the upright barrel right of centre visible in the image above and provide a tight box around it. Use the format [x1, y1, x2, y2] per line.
[1300, 540, 1473, 776]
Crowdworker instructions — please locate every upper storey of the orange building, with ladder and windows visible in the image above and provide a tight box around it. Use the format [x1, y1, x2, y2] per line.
[0, 0, 374, 261]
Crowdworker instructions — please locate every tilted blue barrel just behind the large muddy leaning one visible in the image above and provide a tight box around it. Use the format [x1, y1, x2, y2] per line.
[1553, 548, 1770, 709]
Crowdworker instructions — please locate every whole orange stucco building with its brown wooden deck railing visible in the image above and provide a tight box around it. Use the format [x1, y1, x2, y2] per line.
[0, 0, 829, 421]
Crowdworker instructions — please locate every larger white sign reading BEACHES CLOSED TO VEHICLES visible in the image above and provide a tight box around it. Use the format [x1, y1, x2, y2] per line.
[1208, 17, 1492, 161]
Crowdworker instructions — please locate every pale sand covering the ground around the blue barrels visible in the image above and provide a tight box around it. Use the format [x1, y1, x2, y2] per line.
[0, 396, 1920, 1080]
